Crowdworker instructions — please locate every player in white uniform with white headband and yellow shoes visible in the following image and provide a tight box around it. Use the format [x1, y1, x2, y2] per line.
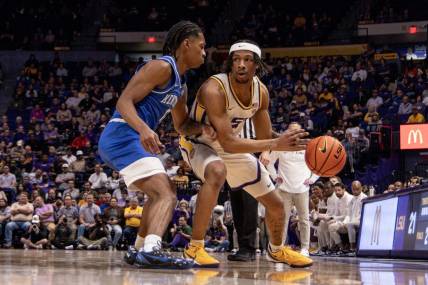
[180, 41, 312, 267]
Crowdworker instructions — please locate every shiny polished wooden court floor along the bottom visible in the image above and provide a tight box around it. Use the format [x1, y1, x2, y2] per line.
[0, 247, 428, 285]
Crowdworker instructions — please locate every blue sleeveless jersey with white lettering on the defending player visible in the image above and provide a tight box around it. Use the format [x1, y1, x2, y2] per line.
[112, 56, 185, 130]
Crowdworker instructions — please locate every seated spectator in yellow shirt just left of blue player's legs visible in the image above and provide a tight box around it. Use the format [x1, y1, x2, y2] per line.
[123, 197, 143, 244]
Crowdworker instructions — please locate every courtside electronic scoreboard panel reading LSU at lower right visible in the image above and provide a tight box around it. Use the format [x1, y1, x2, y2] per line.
[357, 186, 428, 259]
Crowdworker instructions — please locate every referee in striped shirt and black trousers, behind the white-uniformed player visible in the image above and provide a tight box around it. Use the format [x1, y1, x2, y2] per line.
[225, 118, 258, 262]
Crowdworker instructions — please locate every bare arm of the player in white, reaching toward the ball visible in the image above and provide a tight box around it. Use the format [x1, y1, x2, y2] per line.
[199, 79, 307, 153]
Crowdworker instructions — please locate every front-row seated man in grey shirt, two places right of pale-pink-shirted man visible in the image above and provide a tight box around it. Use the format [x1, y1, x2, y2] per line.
[55, 195, 79, 239]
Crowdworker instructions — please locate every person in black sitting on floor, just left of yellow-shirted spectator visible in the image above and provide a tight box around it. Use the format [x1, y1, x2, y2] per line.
[77, 214, 110, 249]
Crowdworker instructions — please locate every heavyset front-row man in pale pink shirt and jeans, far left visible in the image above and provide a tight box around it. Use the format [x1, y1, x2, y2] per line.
[4, 192, 34, 248]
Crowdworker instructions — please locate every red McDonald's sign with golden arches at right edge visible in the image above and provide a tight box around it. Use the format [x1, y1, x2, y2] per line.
[400, 124, 428, 149]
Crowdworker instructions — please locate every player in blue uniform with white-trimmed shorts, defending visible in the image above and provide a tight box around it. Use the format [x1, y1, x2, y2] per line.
[98, 21, 215, 269]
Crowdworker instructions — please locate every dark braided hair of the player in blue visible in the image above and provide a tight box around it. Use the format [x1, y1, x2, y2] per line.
[163, 21, 202, 57]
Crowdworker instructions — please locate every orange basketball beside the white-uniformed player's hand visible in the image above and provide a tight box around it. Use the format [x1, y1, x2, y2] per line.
[305, 136, 346, 177]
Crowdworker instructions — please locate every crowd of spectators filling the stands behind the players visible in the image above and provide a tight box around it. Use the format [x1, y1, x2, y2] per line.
[0, 46, 428, 252]
